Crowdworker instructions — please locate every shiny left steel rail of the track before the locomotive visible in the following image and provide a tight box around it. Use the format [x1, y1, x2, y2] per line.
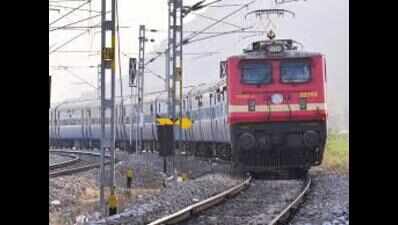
[148, 177, 252, 225]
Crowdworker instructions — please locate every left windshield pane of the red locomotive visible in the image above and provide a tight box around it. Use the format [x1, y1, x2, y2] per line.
[241, 63, 272, 84]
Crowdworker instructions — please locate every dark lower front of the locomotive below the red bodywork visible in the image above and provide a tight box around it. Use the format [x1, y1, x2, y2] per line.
[231, 122, 326, 174]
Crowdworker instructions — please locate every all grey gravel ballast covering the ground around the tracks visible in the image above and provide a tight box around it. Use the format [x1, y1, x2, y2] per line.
[49, 149, 349, 225]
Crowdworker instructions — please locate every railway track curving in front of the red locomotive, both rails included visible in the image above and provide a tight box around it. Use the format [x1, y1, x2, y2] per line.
[149, 177, 311, 225]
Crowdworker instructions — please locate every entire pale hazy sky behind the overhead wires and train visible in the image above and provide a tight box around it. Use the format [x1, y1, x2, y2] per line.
[49, 0, 349, 110]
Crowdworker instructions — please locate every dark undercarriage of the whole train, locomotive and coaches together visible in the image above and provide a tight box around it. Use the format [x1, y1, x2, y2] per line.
[50, 121, 326, 175]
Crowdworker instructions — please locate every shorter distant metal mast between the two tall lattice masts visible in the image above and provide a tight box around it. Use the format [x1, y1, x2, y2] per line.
[137, 25, 145, 151]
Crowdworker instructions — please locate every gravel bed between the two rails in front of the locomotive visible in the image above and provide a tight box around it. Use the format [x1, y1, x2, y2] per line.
[181, 180, 303, 225]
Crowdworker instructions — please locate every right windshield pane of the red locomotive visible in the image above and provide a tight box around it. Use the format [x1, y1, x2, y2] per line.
[281, 62, 310, 83]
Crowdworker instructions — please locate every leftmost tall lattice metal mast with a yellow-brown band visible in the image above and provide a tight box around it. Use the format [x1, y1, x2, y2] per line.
[100, 0, 115, 209]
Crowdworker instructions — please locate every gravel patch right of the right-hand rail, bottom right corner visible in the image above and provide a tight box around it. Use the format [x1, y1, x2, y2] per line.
[290, 169, 349, 225]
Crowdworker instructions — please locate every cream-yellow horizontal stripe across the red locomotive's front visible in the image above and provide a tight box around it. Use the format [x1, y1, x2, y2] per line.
[229, 103, 326, 113]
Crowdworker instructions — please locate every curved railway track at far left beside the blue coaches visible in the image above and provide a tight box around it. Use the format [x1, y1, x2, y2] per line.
[49, 150, 110, 178]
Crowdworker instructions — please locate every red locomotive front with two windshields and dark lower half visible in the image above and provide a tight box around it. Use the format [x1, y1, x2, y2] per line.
[227, 40, 327, 172]
